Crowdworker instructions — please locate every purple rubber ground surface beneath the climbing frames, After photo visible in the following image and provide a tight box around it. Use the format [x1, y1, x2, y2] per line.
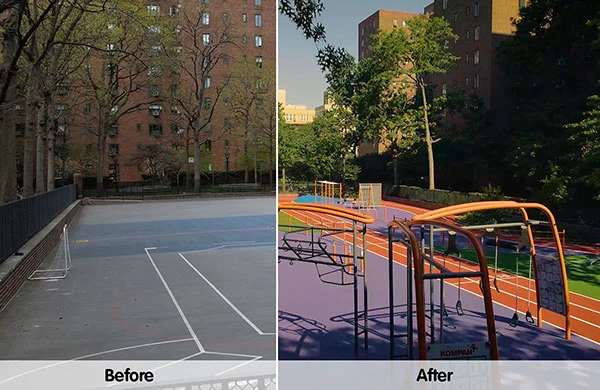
[278, 233, 600, 360]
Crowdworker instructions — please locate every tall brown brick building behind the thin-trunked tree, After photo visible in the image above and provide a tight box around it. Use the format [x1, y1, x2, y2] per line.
[425, 0, 527, 121]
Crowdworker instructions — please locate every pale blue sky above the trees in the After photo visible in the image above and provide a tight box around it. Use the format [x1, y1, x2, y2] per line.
[277, 0, 433, 108]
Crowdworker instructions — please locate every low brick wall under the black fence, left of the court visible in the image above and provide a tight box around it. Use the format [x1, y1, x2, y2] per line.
[0, 200, 81, 311]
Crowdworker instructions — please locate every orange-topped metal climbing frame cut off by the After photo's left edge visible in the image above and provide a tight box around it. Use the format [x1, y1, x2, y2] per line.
[278, 203, 375, 356]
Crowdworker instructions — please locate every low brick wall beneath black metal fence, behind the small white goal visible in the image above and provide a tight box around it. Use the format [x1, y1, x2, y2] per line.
[0, 201, 81, 311]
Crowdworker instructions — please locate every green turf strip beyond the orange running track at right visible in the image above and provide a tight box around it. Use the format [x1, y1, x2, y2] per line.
[436, 247, 600, 299]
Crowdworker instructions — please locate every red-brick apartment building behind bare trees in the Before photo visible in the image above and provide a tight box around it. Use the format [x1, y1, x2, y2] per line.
[17, 0, 276, 182]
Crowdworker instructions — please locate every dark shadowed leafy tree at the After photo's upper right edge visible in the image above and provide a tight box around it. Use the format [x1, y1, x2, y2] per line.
[496, 0, 600, 195]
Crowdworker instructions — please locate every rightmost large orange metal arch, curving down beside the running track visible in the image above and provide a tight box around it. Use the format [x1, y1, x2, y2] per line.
[413, 201, 571, 340]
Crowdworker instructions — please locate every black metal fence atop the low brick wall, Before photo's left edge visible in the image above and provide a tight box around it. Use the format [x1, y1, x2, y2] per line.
[0, 184, 77, 264]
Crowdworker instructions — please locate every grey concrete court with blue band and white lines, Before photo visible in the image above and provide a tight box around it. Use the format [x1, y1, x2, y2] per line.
[0, 197, 276, 360]
